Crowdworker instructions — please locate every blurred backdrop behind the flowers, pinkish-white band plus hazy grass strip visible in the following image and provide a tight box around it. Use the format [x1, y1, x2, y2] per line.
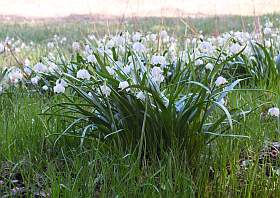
[0, 0, 280, 42]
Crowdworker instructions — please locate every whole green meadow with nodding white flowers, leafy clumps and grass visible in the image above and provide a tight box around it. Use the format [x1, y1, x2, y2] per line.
[0, 15, 280, 197]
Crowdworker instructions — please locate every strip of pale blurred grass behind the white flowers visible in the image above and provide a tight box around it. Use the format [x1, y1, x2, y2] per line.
[0, 13, 279, 43]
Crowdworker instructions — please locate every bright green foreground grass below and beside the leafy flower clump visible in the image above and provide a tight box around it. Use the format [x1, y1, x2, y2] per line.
[0, 88, 280, 197]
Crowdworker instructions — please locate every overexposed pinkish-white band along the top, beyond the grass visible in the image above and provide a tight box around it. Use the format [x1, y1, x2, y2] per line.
[0, 0, 280, 18]
